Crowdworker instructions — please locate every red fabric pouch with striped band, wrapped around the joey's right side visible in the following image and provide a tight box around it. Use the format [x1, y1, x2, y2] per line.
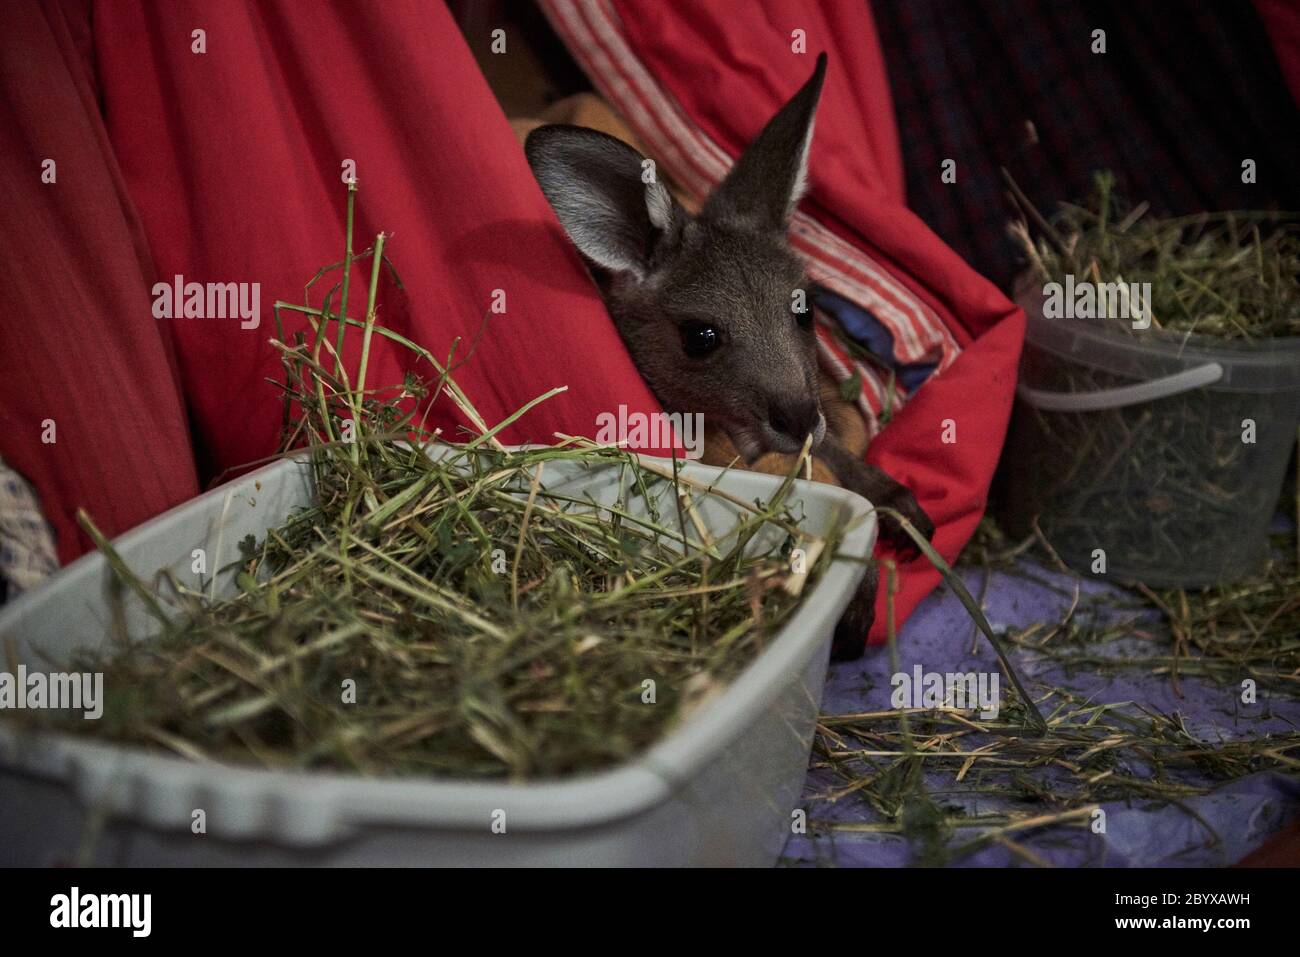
[542, 0, 1024, 644]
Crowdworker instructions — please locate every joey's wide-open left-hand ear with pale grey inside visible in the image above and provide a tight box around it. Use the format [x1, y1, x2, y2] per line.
[524, 124, 685, 278]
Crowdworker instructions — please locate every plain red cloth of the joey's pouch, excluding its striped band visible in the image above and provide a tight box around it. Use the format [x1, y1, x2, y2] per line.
[603, 0, 1024, 642]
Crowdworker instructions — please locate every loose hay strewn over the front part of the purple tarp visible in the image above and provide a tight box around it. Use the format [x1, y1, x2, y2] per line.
[809, 689, 1300, 866]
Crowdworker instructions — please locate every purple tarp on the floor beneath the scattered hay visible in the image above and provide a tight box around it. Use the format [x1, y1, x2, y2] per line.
[784, 546, 1300, 867]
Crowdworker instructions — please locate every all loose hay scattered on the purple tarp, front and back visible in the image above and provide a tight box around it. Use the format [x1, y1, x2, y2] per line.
[807, 519, 1300, 866]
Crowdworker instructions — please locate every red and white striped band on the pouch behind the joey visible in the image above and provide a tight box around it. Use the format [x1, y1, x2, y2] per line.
[541, 0, 961, 436]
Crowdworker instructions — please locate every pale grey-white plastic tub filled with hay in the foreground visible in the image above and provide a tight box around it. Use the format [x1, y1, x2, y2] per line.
[0, 449, 876, 866]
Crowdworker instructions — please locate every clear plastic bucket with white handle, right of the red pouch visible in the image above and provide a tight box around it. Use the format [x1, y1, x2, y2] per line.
[1001, 285, 1300, 586]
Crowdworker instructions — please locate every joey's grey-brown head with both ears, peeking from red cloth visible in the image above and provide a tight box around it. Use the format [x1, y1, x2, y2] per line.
[525, 53, 826, 460]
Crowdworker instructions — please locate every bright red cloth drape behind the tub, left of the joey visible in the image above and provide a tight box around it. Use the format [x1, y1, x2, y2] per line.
[94, 0, 658, 472]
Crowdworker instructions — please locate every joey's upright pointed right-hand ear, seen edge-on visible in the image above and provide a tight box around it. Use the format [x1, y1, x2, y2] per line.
[701, 53, 826, 233]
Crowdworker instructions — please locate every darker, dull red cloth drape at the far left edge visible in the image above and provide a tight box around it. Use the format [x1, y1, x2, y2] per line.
[0, 3, 199, 562]
